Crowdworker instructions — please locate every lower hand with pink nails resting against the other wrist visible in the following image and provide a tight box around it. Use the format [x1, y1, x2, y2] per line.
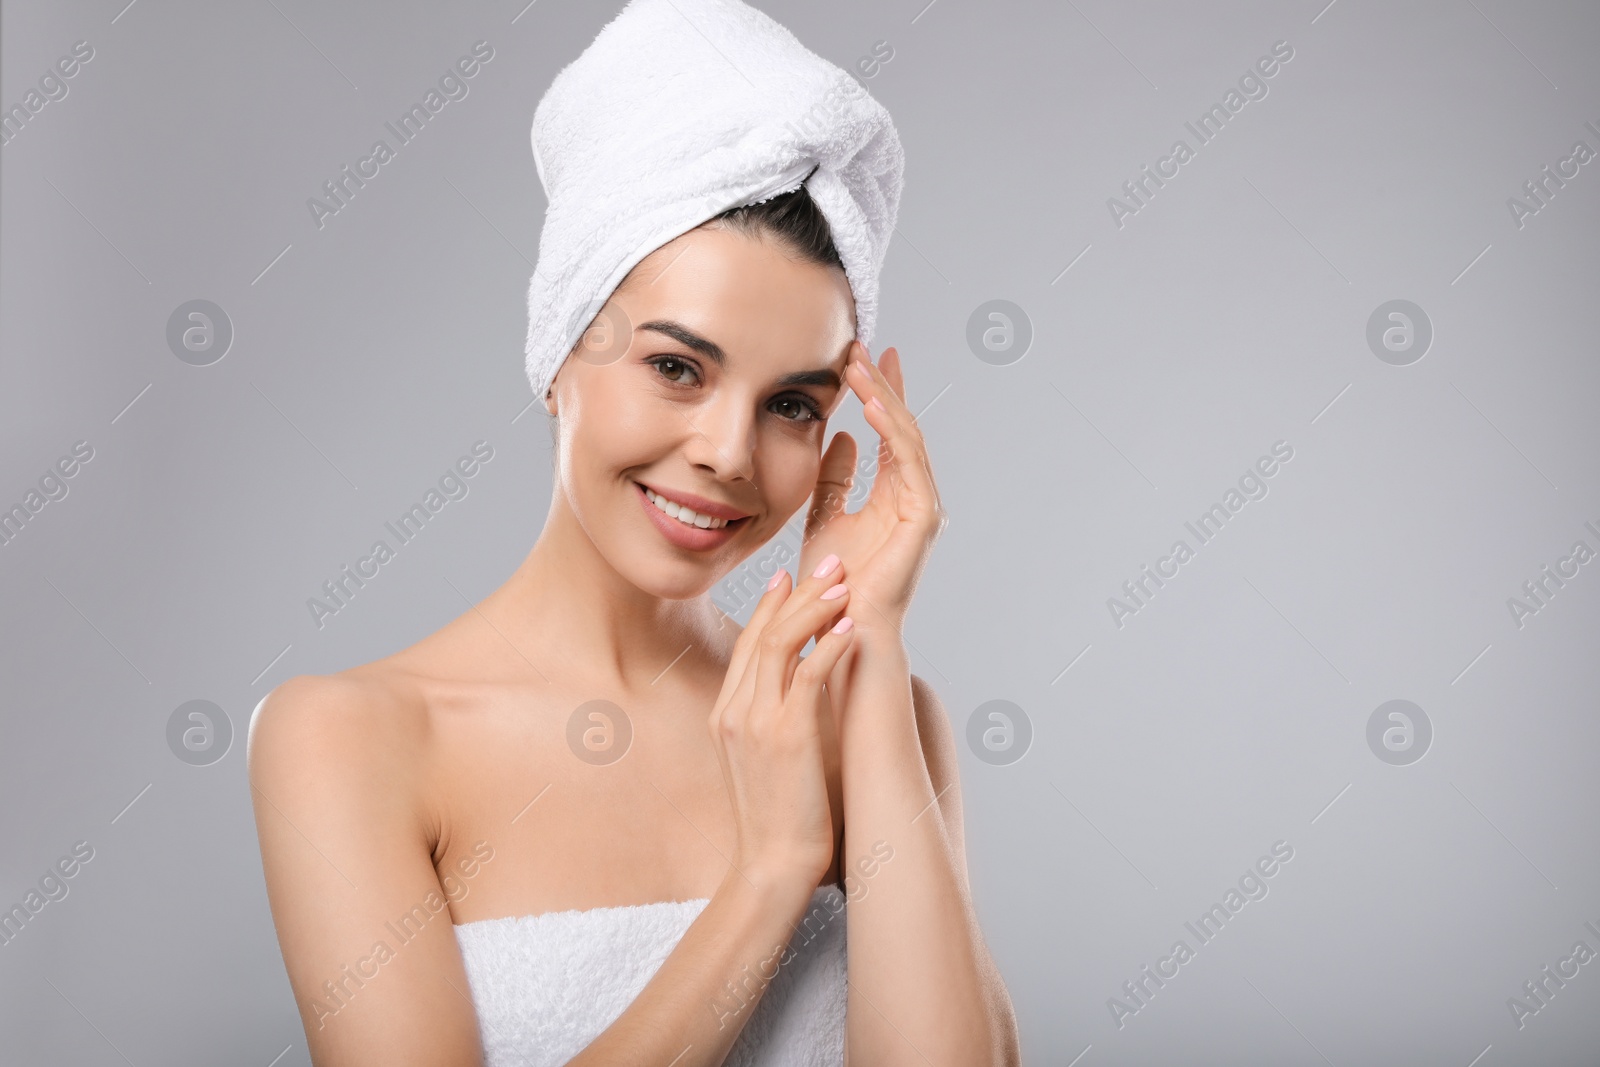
[709, 557, 851, 896]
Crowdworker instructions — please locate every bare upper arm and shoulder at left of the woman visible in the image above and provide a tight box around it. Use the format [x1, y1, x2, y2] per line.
[250, 675, 483, 1067]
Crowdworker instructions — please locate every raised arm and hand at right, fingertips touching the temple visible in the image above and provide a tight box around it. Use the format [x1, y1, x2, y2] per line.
[800, 342, 1019, 1067]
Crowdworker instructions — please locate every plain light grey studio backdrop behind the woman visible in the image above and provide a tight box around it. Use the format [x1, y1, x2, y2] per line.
[0, 0, 1600, 1067]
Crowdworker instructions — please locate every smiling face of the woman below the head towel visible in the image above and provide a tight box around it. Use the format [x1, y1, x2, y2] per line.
[546, 227, 856, 600]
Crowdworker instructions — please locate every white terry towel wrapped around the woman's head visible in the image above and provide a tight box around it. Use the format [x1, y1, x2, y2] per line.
[526, 0, 906, 397]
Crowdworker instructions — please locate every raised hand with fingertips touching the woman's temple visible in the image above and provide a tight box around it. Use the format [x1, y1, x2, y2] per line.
[798, 341, 949, 640]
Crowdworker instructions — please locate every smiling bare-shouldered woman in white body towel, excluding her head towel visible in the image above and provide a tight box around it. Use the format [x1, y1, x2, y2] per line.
[250, 0, 1018, 1067]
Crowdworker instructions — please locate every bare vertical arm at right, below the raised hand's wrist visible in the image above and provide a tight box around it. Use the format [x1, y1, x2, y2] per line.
[840, 639, 1021, 1067]
